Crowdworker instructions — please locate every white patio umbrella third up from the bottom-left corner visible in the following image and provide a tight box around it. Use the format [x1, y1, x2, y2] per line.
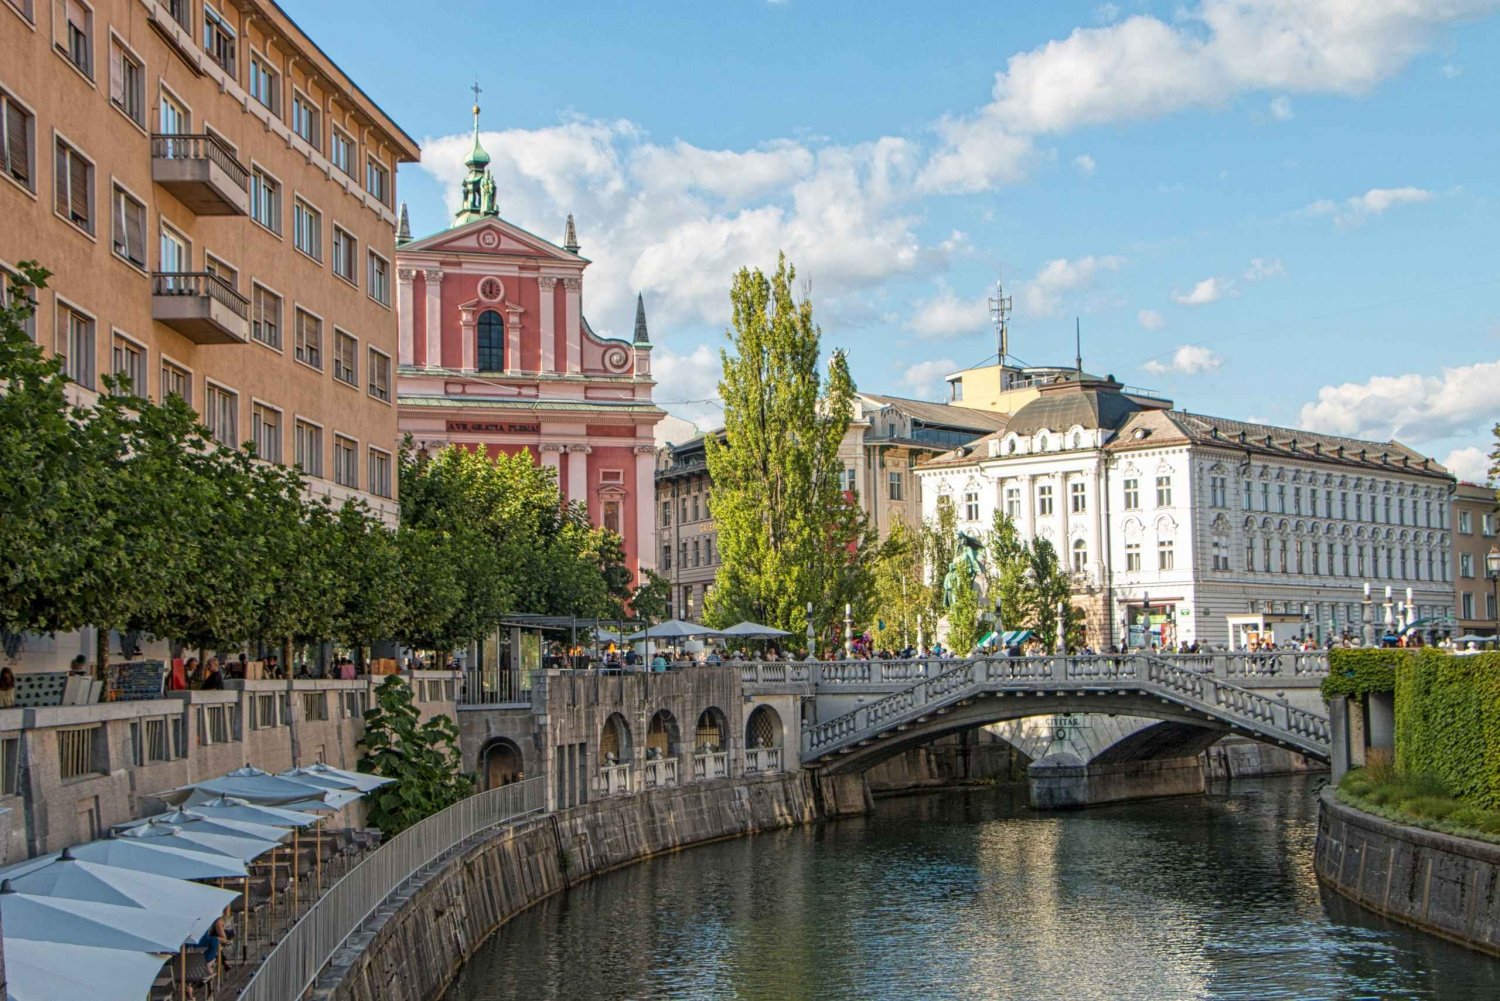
[9, 848, 237, 939]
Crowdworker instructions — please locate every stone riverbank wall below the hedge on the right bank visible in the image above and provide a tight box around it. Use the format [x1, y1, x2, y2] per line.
[1314, 788, 1500, 956]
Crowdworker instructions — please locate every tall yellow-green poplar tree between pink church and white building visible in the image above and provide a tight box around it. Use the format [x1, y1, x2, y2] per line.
[704, 254, 870, 635]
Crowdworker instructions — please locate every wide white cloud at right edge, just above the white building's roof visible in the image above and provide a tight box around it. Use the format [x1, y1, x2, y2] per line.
[1301, 360, 1500, 443]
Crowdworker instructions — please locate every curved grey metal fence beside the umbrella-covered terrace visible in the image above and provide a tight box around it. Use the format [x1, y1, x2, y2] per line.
[240, 779, 546, 1001]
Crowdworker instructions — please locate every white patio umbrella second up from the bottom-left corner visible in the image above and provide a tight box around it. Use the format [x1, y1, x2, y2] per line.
[0, 884, 194, 953]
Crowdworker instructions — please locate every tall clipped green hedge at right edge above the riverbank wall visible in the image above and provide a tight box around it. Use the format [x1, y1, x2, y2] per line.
[1386, 650, 1500, 809]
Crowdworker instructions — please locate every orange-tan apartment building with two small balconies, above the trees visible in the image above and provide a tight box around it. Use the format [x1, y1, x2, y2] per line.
[0, 0, 419, 518]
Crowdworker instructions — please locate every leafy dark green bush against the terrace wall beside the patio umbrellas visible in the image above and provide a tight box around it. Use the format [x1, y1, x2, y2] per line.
[359, 675, 474, 837]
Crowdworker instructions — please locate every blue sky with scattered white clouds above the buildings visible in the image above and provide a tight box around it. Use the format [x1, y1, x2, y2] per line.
[289, 0, 1500, 480]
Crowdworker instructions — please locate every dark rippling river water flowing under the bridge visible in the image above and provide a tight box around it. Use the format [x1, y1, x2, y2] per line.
[447, 777, 1500, 1001]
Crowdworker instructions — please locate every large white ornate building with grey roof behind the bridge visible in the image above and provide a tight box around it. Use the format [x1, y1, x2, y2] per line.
[918, 375, 1454, 647]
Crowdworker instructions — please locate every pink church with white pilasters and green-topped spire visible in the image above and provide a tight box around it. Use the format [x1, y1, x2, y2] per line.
[396, 107, 665, 573]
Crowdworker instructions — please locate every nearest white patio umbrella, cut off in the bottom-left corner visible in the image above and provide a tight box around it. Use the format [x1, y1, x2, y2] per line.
[5, 935, 165, 1001]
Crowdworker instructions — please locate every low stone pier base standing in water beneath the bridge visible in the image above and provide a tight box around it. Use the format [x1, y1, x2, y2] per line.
[1026, 752, 1208, 810]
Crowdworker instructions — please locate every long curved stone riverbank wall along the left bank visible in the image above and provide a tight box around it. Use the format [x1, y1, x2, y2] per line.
[314, 773, 873, 1001]
